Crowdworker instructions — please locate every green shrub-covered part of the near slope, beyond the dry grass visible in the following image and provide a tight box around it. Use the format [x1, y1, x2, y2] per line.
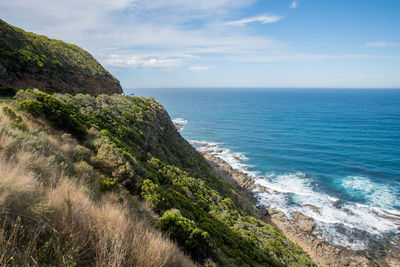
[0, 90, 314, 266]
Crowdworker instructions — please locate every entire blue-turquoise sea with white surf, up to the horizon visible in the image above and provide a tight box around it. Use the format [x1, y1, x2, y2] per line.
[127, 89, 400, 249]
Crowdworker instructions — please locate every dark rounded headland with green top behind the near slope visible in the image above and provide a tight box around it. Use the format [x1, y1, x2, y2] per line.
[0, 20, 122, 95]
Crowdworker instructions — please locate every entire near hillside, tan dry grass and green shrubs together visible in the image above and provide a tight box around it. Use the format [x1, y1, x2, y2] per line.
[0, 90, 314, 266]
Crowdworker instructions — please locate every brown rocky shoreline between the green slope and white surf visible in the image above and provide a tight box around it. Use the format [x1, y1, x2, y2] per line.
[201, 151, 400, 267]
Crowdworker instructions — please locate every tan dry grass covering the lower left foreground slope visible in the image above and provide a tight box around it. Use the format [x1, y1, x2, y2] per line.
[0, 107, 194, 267]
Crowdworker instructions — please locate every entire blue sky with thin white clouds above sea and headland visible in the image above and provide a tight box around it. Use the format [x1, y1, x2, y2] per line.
[0, 0, 400, 88]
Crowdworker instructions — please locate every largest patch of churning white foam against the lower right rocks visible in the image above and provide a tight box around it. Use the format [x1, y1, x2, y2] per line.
[254, 173, 400, 250]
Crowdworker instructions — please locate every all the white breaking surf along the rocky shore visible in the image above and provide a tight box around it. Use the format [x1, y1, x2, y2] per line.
[190, 140, 400, 250]
